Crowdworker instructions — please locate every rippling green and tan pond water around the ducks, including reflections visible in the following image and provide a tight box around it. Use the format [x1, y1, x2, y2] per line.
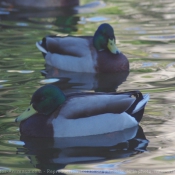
[0, 0, 175, 174]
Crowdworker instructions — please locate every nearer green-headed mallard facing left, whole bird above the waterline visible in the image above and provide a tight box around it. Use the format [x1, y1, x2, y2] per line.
[16, 85, 149, 137]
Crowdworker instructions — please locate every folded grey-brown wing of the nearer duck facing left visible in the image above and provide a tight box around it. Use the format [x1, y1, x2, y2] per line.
[59, 94, 135, 119]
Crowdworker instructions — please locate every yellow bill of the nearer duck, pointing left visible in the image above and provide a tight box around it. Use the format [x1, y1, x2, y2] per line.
[15, 104, 37, 122]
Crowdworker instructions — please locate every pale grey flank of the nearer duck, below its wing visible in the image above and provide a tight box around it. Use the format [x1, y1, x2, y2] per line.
[52, 112, 138, 137]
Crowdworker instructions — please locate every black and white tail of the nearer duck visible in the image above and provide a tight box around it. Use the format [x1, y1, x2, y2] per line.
[126, 91, 149, 122]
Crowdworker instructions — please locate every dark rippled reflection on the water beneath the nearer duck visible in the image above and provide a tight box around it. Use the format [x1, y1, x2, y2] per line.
[18, 126, 149, 174]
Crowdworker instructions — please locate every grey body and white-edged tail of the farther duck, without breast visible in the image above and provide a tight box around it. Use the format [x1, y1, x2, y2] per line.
[36, 36, 97, 73]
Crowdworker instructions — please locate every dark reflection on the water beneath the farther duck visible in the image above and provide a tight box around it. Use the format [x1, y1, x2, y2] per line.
[41, 65, 129, 92]
